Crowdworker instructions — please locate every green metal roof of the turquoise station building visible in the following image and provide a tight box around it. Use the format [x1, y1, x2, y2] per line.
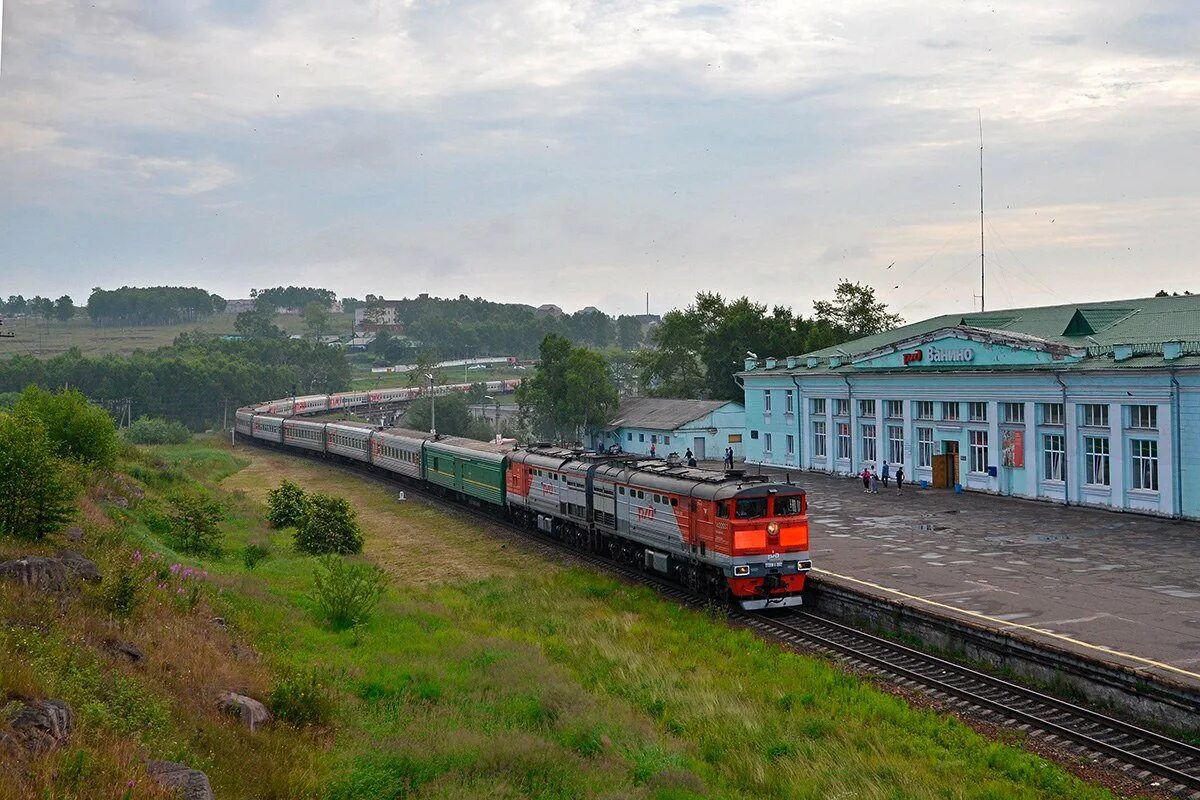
[740, 295, 1200, 374]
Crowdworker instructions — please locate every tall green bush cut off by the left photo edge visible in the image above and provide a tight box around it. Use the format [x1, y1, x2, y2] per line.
[0, 409, 77, 539]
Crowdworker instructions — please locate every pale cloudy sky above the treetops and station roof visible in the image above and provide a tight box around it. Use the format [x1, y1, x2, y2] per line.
[0, 0, 1200, 320]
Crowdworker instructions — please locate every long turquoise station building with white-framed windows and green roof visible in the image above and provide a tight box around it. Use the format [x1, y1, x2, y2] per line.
[738, 295, 1200, 519]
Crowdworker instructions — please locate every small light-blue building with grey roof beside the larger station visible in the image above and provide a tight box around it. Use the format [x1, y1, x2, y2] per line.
[596, 397, 746, 459]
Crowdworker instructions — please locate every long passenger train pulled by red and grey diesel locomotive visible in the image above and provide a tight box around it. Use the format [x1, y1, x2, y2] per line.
[235, 381, 812, 610]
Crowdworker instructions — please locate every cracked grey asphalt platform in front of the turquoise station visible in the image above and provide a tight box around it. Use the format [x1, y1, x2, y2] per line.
[700, 464, 1200, 685]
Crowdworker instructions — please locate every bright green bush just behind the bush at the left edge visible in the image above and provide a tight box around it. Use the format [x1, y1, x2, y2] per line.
[16, 386, 120, 467]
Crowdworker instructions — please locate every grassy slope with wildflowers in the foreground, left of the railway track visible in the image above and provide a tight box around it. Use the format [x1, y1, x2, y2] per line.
[0, 441, 1111, 800]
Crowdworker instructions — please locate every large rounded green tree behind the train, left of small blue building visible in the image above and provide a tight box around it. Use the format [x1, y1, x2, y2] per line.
[517, 333, 618, 440]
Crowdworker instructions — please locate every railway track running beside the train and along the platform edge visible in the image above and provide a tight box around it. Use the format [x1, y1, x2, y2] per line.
[246, 443, 1200, 800]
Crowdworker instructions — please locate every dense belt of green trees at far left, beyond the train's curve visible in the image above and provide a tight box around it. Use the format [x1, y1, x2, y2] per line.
[0, 333, 350, 431]
